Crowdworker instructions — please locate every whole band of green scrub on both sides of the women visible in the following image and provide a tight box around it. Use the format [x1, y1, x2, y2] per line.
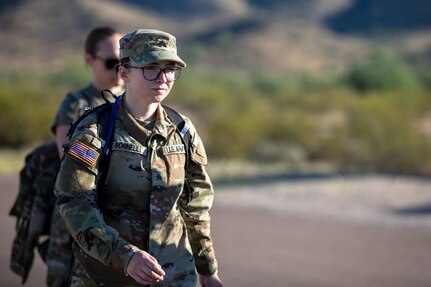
[0, 51, 431, 175]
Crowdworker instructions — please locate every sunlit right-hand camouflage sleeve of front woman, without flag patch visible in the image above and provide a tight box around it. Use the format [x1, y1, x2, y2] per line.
[182, 118, 217, 276]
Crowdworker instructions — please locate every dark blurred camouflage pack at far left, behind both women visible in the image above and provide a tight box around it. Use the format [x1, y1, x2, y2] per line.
[9, 141, 59, 283]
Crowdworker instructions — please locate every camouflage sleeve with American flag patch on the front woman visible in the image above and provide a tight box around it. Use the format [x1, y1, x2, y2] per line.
[55, 118, 138, 273]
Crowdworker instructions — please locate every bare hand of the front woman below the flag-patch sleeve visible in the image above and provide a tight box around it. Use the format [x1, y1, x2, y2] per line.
[127, 250, 165, 285]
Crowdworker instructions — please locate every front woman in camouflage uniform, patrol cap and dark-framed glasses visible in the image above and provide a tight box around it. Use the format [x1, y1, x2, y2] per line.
[55, 29, 222, 287]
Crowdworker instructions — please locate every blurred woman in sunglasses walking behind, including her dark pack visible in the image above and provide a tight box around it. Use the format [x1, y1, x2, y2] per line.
[10, 27, 122, 286]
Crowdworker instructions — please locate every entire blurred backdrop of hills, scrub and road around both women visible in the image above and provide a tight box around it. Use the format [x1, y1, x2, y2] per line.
[0, 0, 431, 287]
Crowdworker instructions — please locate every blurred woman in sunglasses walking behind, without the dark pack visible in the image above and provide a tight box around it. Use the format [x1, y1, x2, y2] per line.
[46, 27, 122, 286]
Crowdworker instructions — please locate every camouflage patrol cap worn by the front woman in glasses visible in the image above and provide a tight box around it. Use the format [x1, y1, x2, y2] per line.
[120, 29, 186, 68]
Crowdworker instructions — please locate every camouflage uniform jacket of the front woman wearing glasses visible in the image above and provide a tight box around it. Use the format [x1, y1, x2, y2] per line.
[55, 98, 217, 286]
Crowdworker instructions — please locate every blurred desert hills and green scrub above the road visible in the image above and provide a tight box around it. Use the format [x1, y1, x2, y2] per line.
[0, 0, 431, 175]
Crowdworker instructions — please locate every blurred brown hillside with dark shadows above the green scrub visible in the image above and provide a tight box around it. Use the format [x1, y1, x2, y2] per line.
[0, 0, 431, 72]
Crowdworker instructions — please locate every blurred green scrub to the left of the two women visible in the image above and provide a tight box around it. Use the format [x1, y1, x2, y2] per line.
[0, 56, 90, 148]
